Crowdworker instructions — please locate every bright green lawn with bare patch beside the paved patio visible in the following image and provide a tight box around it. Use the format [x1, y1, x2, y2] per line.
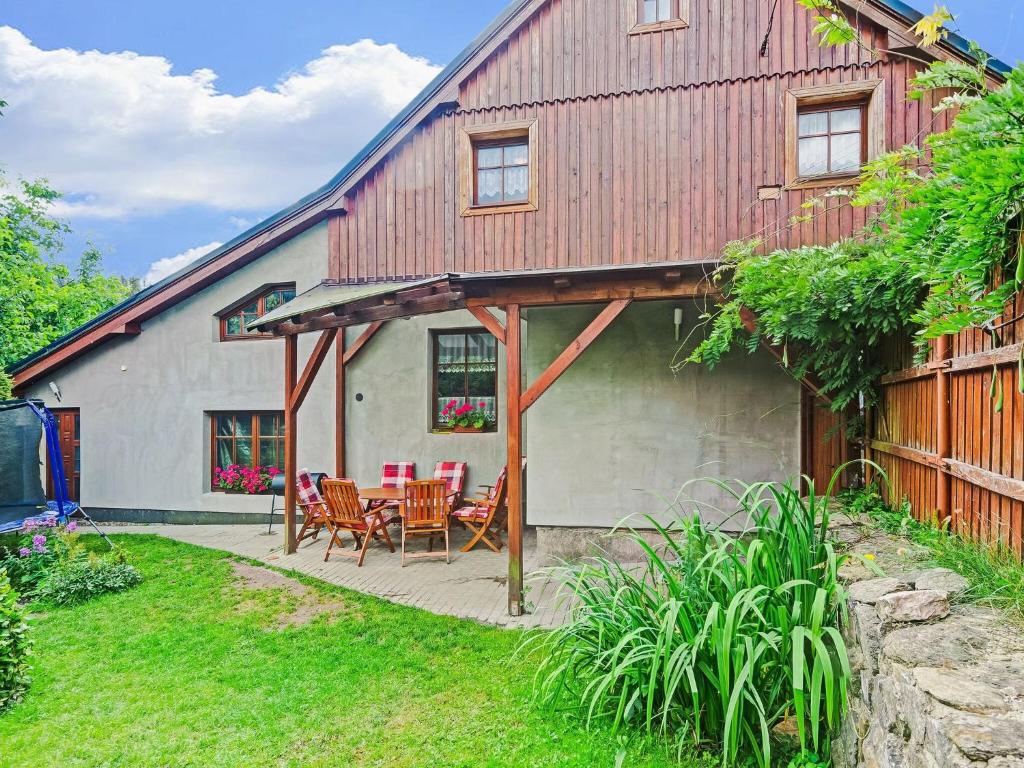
[0, 536, 710, 768]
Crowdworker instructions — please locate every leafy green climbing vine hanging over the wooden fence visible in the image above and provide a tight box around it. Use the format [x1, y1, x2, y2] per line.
[679, 6, 1024, 411]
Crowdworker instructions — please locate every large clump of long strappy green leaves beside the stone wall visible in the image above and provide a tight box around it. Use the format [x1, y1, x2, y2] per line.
[527, 480, 850, 766]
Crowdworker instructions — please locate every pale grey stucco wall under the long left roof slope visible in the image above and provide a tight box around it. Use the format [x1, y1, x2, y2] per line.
[26, 224, 334, 512]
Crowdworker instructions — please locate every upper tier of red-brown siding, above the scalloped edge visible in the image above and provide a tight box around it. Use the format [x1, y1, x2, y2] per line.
[460, 0, 886, 109]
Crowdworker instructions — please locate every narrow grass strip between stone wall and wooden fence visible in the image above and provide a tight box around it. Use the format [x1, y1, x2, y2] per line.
[843, 487, 1024, 625]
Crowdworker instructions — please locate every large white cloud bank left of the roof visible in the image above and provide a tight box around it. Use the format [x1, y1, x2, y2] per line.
[0, 27, 438, 218]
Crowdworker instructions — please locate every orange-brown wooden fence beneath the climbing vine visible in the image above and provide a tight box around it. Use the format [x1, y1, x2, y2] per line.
[866, 294, 1024, 554]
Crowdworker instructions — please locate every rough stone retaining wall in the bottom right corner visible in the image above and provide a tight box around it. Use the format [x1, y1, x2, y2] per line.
[833, 535, 1024, 768]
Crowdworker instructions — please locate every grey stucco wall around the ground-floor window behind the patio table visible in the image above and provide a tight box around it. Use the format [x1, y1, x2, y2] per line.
[342, 311, 505, 499]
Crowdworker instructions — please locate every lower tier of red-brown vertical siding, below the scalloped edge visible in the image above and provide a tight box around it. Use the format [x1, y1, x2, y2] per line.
[331, 56, 944, 281]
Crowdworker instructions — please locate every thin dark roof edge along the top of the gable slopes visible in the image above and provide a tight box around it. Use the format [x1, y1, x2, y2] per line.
[8, 0, 1012, 374]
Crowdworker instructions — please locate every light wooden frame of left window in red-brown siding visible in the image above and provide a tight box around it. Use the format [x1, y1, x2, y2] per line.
[458, 120, 540, 216]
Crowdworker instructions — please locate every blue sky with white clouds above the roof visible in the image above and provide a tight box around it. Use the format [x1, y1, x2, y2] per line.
[0, 0, 1024, 276]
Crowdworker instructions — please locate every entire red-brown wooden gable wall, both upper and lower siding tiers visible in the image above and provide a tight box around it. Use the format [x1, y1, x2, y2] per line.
[330, 0, 945, 281]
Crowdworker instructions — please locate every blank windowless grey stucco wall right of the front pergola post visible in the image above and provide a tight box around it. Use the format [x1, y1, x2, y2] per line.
[524, 302, 800, 526]
